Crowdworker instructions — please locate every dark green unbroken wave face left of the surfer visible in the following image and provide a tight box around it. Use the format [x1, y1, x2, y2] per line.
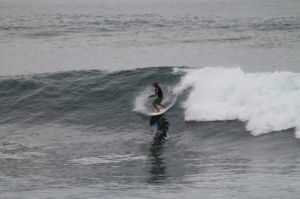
[0, 67, 179, 128]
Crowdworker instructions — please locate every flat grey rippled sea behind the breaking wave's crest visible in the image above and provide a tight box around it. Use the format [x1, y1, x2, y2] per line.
[0, 0, 300, 75]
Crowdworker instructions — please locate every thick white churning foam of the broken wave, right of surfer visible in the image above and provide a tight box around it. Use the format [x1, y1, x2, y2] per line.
[175, 67, 300, 138]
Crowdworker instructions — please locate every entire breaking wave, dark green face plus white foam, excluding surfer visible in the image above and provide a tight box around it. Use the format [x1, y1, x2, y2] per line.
[0, 67, 300, 138]
